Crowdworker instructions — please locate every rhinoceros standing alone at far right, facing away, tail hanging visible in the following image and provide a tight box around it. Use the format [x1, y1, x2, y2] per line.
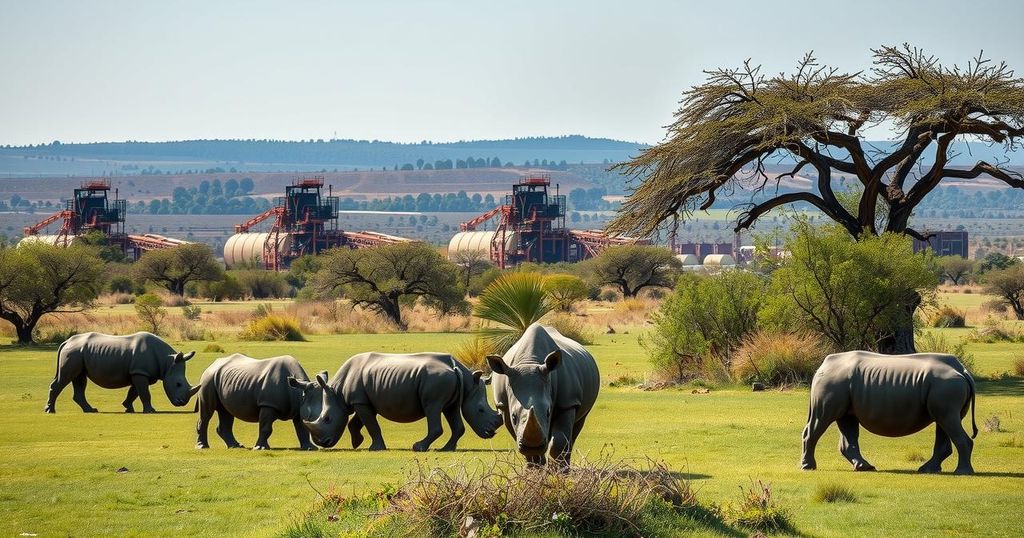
[801, 351, 978, 474]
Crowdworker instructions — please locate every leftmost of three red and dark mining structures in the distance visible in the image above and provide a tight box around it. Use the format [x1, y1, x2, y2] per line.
[20, 179, 187, 259]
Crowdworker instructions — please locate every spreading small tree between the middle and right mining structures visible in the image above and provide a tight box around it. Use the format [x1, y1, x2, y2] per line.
[315, 243, 464, 328]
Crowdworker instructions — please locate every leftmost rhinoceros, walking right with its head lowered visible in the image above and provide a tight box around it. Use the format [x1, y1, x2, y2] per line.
[45, 332, 199, 413]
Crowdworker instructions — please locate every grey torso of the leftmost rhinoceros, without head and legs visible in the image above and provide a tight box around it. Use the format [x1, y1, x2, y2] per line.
[74, 332, 173, 388]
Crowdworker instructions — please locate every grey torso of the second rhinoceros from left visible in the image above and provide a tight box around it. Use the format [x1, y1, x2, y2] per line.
[203, 354, 309, 422]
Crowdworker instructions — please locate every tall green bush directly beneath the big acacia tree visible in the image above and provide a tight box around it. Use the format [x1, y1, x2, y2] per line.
[764, 221, 938, 350]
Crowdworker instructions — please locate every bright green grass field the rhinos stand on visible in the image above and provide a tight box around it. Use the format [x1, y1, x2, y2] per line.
[0, 325, 1024, 536]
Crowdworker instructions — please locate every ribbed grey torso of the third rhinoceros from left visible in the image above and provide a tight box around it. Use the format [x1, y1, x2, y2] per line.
[333, 353, 459, 422]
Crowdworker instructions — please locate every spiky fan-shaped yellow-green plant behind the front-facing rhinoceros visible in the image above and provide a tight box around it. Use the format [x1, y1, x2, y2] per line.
[473, 272, 551, 353]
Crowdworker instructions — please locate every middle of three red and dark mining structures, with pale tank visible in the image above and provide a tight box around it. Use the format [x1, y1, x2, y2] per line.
[224, 175, 410, 271]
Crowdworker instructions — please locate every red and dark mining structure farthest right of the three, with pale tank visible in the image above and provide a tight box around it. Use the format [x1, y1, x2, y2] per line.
[447, 175, 649, 268]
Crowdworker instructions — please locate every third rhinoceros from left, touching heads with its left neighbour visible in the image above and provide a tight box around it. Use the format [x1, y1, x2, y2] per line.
[293, 353, 502, 452]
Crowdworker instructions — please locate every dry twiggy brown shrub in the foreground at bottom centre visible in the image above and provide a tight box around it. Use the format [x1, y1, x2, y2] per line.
[382, 453, 698, 536]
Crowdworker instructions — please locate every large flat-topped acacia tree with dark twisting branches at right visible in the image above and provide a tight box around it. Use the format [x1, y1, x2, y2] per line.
[608, 45, 1024, 351]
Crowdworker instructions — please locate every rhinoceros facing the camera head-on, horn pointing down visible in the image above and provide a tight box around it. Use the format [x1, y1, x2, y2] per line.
[487, 323, 601, 466]
